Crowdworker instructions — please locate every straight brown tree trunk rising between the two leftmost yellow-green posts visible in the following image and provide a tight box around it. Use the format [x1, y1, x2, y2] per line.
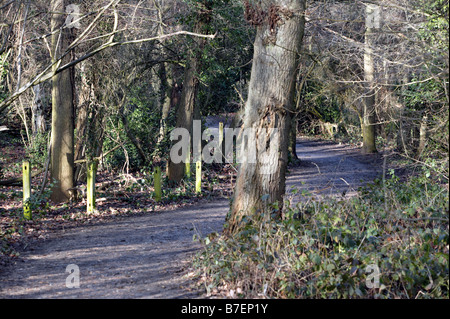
[50, 0, 74, 203]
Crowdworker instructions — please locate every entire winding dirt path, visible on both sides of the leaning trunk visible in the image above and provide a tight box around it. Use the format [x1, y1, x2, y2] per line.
[0, 140, 378, 299]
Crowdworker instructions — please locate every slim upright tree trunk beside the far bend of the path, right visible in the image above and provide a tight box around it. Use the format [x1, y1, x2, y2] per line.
[362, 4, 379, 153]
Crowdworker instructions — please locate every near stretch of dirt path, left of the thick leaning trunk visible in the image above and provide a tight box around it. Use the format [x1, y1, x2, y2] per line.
[0, 199, 228, 299]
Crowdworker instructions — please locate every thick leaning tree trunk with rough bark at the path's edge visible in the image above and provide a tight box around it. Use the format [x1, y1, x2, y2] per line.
[226, 0, 305, 234]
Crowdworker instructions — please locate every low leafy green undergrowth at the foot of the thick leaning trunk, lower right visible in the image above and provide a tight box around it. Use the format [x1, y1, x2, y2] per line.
[194, 172, 449, 298]
